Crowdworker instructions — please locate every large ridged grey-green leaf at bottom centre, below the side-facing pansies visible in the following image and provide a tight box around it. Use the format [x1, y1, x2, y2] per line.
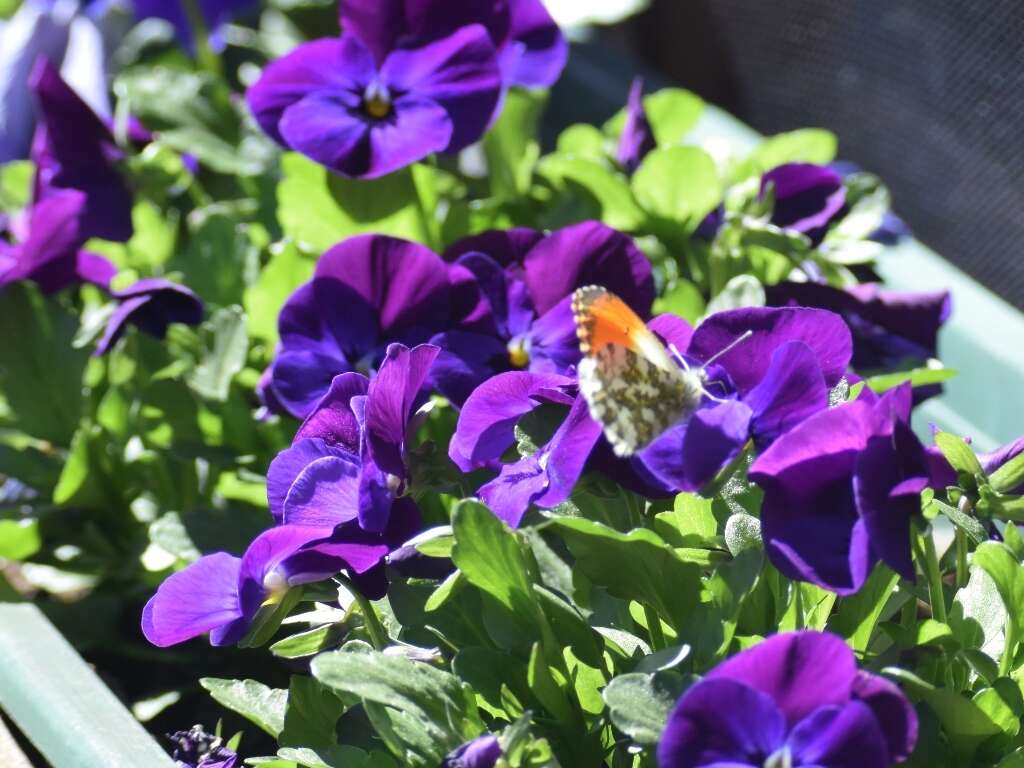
[311, 649, 483, 768]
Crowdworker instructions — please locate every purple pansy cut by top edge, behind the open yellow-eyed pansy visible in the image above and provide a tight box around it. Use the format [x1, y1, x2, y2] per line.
[341, 0, 568, 88]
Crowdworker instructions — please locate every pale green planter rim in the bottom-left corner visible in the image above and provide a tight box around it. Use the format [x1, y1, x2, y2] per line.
[0, 603, 174, 768]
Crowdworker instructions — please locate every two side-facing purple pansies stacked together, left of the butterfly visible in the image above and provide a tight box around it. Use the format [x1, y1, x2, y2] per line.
[142, 345, 436, 647]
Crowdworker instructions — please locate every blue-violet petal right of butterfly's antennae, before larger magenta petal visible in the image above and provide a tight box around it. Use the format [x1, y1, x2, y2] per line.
[743, 341, 828, 450]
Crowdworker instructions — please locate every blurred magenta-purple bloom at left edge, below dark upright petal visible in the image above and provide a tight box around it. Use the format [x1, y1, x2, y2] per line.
[0, 189, 117, 293]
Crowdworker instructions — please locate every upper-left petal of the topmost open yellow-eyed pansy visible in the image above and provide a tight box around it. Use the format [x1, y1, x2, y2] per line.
[246, 35, 376, 142]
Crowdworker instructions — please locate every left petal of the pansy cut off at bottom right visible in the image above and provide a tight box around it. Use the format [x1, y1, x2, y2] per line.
[657, 679, 786, 768]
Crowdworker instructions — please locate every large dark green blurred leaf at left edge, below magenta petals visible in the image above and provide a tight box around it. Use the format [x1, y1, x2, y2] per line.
[0, 283, 89, 446]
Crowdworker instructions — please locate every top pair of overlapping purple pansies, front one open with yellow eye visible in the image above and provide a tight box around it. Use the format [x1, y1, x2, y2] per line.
[248, 0, 567, 178]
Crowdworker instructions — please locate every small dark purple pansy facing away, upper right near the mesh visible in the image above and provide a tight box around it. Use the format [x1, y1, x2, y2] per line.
[761, 163, 846, 245]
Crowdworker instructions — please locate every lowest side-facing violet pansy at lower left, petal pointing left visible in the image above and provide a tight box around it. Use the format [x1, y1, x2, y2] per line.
[142, 525, 389, 648]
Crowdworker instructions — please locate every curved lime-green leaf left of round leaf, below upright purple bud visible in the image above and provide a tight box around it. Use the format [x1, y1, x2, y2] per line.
[537, 154, 643, 229]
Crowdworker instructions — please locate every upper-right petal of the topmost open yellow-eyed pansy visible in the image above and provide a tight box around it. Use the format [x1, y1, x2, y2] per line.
[381, 25, 502, 152]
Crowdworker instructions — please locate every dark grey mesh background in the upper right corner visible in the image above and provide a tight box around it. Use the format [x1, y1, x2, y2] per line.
[630, 0, 1024, 307]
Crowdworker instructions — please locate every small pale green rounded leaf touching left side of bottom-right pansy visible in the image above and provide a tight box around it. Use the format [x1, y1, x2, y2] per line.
[603, 673, 682, 746]
